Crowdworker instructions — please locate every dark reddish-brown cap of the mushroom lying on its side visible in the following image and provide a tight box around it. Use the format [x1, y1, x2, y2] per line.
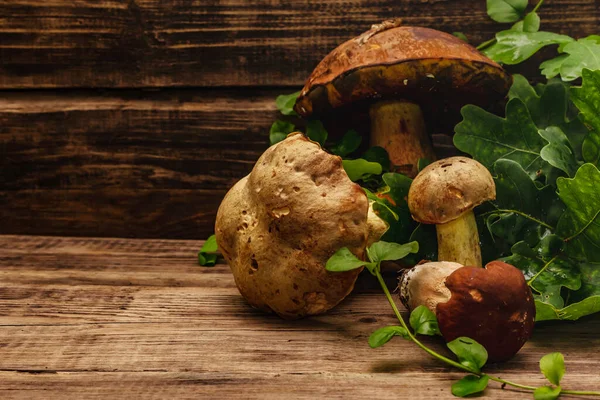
[437, 261, 535, 361]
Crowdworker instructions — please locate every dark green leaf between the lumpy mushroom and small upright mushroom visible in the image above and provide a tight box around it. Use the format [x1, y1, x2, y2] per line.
[373, 172, 416, 243]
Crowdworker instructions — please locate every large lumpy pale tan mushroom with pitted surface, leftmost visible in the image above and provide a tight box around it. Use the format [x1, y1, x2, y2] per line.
[215, 134, 387, 319]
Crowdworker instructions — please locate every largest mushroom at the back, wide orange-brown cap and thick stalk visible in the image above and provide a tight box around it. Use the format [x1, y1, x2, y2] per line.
[294, 21, 512, 177]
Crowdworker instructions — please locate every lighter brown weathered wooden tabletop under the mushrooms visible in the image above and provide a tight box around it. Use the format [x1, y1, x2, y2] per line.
[0, 236, 600, 399]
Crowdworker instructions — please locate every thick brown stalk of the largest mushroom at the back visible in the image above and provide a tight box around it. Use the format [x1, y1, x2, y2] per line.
[369, 100, 436, 178]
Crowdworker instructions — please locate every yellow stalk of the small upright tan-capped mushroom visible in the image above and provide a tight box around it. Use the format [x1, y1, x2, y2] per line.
[436, 210, 482, 267]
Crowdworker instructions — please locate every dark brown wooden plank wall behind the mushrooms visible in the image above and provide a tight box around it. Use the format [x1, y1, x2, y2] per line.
[0, 0, 600, 238]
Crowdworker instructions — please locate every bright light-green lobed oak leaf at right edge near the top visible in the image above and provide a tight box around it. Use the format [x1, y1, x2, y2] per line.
[540, 35, 600, 82]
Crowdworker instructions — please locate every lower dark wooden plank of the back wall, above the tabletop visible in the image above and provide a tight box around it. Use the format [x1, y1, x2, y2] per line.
[0, 90, 452, 239]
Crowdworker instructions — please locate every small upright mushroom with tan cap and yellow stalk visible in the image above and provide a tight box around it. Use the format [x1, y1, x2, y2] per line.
[408, 157, 496, 267]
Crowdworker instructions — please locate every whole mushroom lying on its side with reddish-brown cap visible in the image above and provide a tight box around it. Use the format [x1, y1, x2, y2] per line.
[398, 261, 535, 361]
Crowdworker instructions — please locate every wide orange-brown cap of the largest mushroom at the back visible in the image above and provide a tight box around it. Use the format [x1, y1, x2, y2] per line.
[295, 21, 512, 117]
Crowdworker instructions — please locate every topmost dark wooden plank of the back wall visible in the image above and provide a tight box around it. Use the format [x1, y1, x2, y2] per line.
[0, 0, 600, 88]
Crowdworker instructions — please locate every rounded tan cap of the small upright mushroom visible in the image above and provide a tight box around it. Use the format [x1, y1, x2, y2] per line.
[408, 157, 496, 224]
